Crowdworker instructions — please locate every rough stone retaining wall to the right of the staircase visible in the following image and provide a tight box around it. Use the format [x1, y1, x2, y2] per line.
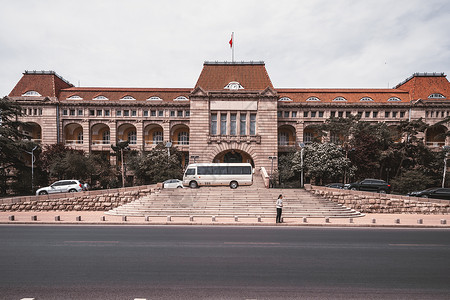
[305, 185, 450, 214]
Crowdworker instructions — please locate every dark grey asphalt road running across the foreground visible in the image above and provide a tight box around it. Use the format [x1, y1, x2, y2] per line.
[0, 225, 450, 300]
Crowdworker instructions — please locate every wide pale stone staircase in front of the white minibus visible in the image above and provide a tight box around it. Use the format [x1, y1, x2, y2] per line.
[107, 175, 363, 218]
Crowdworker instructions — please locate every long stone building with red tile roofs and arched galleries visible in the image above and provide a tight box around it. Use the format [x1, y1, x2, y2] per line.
[8, 62, 450, 169]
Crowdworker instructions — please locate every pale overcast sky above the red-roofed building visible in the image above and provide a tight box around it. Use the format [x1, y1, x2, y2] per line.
[0, 0, 450, 96]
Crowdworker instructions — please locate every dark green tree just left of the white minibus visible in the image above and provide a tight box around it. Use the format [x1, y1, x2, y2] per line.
[127, 144, 183, 184]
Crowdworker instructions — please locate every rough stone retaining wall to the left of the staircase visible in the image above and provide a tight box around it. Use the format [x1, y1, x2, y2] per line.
[0, 185, 160, 211]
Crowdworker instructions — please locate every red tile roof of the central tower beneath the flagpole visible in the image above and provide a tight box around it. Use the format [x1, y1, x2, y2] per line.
[195, 62, 273, 91]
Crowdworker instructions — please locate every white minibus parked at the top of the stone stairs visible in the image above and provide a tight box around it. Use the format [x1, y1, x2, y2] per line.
[183, 163, 253, 189]
